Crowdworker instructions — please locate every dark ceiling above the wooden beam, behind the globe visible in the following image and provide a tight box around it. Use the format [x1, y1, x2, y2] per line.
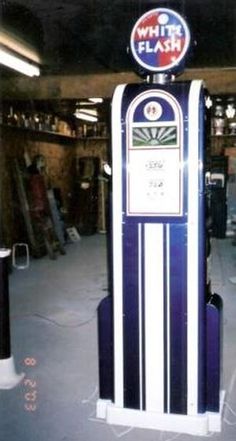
[0, 0, 236, 74]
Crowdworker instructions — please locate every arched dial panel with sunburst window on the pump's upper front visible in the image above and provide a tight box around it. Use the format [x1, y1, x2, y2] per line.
[126, 90, 183, 217]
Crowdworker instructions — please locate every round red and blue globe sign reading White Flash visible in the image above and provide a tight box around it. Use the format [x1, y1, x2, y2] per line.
[130, 8, 190, 73]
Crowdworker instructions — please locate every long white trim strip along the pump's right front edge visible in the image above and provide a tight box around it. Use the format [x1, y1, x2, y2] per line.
[187, 80, 202, 415]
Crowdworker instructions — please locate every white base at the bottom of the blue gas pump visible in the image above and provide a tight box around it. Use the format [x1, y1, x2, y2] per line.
[97, 392, 225, 436]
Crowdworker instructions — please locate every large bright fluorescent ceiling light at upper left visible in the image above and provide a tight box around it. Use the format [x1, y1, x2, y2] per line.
[0, 47, 40, 77]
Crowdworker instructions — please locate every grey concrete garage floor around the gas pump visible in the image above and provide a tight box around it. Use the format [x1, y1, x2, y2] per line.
[0, 235, 236, 441]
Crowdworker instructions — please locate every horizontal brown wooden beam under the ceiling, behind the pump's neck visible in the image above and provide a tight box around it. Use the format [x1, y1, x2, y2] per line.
[1, 68, 236, 99]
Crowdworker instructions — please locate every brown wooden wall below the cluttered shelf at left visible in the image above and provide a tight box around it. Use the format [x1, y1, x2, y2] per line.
[0, 127, 107, 247]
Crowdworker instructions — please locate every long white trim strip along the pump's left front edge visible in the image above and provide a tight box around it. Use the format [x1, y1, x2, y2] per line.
[112, 85, 125, 407]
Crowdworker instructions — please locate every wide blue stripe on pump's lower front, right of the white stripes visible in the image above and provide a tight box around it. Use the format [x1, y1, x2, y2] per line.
[170, 224, 187, 414]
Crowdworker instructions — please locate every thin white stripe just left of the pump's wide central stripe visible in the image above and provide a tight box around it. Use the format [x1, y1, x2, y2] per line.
[138, 224, 143, 409]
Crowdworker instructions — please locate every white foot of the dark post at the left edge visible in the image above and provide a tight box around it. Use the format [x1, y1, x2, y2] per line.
[0, 356, 25, 389]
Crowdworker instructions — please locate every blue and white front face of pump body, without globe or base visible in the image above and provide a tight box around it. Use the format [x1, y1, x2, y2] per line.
[112, 83, 205, 414]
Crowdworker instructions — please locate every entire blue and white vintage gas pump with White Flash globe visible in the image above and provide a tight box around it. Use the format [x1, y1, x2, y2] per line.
[97, 8, 223, 435]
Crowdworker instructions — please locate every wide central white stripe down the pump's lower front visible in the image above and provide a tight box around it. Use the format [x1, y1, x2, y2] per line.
[144, 224, 164, 413]
